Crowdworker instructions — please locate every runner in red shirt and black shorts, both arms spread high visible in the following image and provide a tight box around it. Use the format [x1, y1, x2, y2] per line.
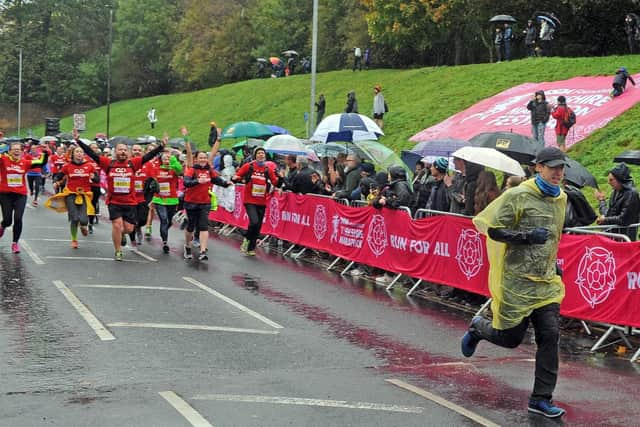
[74, 130, 164, 261]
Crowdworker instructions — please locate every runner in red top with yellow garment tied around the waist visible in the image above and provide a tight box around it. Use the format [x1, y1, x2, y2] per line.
[45, 147, 96, 249]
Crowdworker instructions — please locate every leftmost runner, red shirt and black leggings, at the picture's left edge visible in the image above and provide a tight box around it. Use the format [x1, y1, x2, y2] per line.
[0, 142, 48, 254]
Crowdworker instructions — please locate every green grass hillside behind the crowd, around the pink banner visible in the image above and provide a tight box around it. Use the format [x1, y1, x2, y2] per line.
[34, 56, 640, 187]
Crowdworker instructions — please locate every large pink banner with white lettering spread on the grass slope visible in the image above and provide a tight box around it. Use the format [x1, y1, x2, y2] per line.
[411, 74, 640, 147]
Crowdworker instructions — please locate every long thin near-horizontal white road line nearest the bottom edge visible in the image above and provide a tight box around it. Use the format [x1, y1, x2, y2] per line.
[193, 394, 424, 414]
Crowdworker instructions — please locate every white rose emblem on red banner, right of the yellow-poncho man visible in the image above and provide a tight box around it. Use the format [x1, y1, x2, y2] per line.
[576, 246, 616, 308]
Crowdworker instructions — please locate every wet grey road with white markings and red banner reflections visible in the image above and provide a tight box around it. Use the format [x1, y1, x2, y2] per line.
[0, 199, 640, 426]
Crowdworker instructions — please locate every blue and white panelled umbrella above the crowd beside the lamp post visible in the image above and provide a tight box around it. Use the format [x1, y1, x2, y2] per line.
[310, 113, 384, 142]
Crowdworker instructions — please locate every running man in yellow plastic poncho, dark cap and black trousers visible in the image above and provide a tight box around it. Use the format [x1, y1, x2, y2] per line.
[461, 147, 567, 418]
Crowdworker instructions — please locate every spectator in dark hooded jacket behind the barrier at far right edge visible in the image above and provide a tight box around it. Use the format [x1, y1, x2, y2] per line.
[595, 162, 640, 242]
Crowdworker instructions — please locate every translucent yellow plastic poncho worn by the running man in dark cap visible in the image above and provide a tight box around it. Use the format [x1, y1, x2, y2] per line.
[473, 179, 567, 330]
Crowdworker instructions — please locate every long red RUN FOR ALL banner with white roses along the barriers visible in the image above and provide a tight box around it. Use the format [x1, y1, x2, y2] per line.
[210, 187, 640, 327]
